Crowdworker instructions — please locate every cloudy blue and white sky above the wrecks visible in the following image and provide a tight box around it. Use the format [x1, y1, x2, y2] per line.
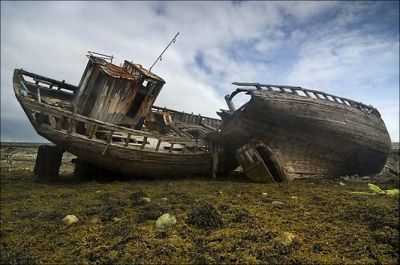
[1, 1, 399, 142]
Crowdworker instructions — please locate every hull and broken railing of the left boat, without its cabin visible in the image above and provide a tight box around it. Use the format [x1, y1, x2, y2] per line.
[13, 69, 221, 178]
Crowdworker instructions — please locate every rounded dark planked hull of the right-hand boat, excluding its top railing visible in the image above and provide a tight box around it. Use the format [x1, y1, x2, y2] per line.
[217, 90, 391, 179]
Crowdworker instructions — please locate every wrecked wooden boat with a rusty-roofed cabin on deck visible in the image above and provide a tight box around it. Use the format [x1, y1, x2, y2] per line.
[13, 52, 221, 177]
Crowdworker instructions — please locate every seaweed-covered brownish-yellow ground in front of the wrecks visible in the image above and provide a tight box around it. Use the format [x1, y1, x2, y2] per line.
[0, 143, 399, 264]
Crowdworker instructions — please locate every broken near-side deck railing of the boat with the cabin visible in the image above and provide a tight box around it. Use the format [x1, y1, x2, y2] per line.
[23, 99, 210, 154]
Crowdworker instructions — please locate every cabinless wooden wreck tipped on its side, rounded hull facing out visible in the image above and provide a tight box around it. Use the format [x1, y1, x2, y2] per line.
[213, 83, 391, 181]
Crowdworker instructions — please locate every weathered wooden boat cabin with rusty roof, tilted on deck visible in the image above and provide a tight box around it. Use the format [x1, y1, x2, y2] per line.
[73, 52, 165, 129]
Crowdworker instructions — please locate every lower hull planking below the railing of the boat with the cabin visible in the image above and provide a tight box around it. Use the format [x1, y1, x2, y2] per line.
[35, 126, 212, 178]
